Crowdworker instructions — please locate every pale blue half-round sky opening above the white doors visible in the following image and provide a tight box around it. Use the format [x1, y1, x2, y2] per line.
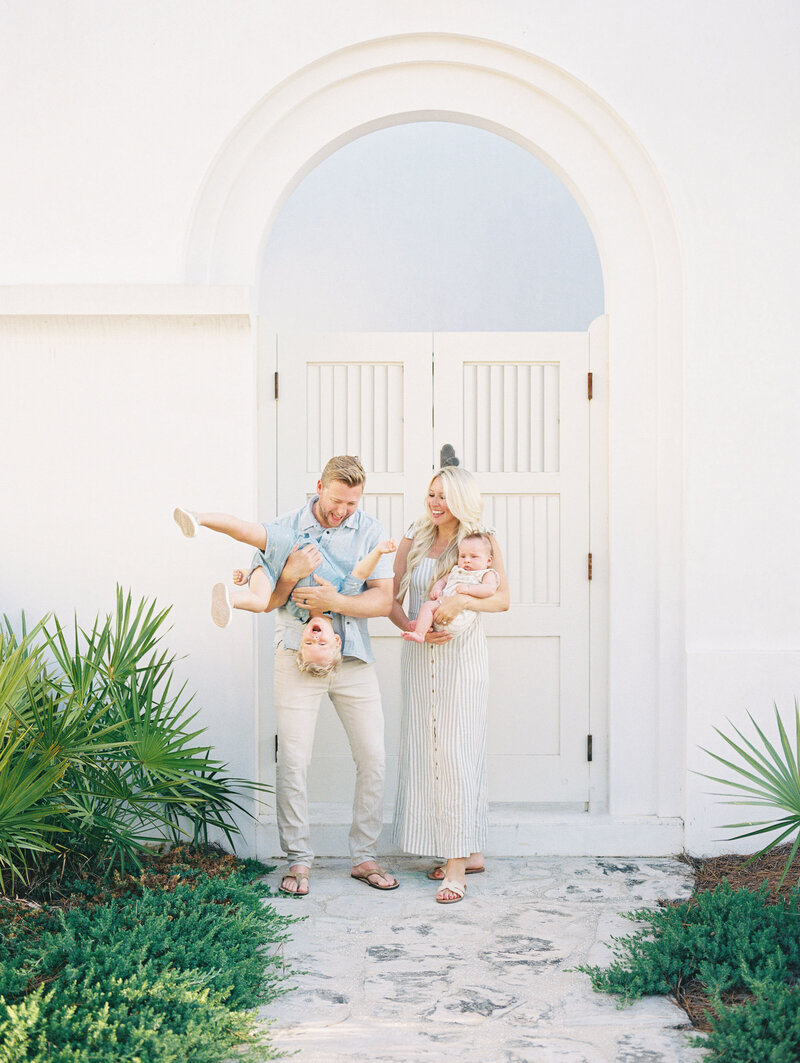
[259, 122, 603, 332]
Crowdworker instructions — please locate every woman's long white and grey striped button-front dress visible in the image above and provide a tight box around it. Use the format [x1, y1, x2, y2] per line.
[392, 558, 489, 859]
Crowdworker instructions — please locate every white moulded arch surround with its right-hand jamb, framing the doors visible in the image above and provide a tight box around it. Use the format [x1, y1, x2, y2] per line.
[187, 35, 684, 853]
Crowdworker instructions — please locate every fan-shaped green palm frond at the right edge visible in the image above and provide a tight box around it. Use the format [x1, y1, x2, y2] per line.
[697, 699, 800, 884]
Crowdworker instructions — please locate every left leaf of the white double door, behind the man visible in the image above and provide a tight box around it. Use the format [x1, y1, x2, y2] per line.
[276, 333, 432, 805]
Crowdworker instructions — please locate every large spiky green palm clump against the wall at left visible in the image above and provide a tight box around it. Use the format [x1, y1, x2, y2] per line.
[0, 588, 269, 890]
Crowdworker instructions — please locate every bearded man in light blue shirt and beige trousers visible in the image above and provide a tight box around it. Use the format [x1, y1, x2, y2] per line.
[263, 455, 399, 897]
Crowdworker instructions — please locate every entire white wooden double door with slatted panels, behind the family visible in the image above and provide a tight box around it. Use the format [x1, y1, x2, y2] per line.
[276, 333, 591, 808]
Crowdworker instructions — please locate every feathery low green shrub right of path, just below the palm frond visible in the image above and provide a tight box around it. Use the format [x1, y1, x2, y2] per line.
[579, 882, 800, 1002]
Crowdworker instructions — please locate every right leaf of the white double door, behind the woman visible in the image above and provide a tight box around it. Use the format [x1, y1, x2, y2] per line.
[433, 333, 590, 808]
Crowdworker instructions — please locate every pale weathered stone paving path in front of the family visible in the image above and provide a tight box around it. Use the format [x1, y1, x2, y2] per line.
[259, 857, 704, 1063]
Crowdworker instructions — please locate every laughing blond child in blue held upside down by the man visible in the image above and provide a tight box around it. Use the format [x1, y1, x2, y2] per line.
[172, 506, 397, 676]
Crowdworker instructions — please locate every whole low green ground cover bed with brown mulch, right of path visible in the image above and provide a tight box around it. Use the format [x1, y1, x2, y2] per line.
[580, 847, 800, 1063]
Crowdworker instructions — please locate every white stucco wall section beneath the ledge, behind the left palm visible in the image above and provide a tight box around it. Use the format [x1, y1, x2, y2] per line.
[0, 301, 256, 846]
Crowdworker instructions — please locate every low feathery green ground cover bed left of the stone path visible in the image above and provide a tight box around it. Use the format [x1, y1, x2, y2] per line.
[0, 849, 294, 1063]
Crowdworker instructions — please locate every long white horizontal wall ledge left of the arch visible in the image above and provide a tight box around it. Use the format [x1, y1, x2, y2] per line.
[0, 284, 253, 317]
